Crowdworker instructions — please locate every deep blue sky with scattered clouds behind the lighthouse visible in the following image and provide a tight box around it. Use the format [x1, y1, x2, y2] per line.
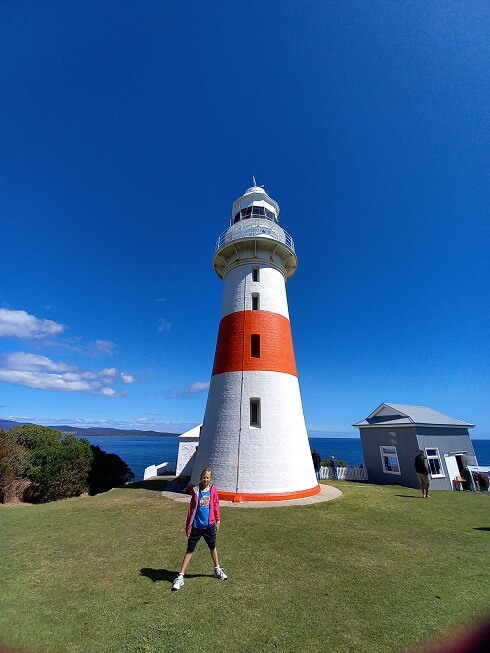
[0, 0, 490, 437]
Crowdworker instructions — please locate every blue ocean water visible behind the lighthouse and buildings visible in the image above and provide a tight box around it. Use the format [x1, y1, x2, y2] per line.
[76, 435, 490, 480]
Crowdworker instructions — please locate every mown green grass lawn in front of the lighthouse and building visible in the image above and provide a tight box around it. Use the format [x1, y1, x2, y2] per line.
[0, 481, 490, 653]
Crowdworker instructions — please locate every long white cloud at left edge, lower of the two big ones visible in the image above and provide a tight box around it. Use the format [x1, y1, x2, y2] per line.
[0, 352, 125, 397]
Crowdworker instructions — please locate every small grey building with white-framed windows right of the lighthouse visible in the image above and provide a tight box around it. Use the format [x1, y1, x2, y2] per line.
[352, 404, 478, 490]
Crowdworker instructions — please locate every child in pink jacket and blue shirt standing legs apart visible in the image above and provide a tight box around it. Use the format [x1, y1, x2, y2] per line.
[172, 468, 228, 592]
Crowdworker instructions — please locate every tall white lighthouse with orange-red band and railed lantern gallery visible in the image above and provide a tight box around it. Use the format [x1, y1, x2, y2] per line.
[191, 185, 320, 502]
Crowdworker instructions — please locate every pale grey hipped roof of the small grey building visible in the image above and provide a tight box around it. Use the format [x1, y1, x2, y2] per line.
[352, 404, 475, 428]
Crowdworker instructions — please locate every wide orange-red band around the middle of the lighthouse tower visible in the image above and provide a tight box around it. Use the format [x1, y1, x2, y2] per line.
[213, 311, 298, 376]
